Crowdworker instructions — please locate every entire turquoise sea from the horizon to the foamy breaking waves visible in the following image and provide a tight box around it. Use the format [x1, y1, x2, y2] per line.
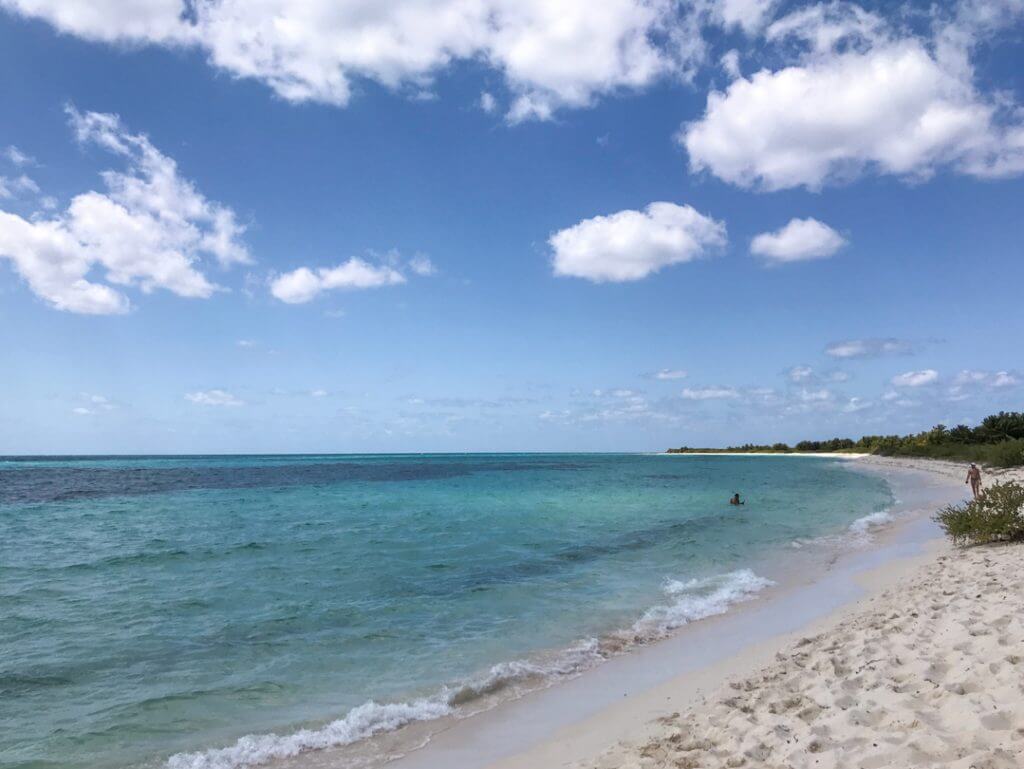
[0, 455, 892, 769]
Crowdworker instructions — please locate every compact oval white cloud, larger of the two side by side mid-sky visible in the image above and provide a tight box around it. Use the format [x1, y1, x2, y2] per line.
[548, 203, 726, 283]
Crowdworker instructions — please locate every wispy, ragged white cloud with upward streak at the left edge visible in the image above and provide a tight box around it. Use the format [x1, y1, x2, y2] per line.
[0, 109, 250, 314]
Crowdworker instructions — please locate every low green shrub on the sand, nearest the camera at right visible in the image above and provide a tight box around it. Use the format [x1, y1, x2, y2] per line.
[935, 481, 1024, 545]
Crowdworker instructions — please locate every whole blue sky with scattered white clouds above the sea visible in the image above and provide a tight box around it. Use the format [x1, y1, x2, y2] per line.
[0, 0, 1024, 455]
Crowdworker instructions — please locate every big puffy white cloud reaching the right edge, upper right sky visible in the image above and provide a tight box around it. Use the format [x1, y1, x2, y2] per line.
[679, 3, 1024, 190]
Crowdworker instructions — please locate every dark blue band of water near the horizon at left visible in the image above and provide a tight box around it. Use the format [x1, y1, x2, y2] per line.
[0, 457, 586, 505]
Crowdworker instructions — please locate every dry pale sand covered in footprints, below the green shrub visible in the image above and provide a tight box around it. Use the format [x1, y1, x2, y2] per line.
[574, 460, 1024, 769]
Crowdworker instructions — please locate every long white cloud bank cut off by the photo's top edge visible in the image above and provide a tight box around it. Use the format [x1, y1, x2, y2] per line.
[3, 0, 700, 120]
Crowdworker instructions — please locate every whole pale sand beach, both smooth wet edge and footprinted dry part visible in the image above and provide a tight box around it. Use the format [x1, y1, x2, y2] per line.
[385, 457, 1024, 769]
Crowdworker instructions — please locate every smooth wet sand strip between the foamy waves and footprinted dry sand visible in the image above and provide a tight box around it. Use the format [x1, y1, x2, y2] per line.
[378, 455, 963, 769]
